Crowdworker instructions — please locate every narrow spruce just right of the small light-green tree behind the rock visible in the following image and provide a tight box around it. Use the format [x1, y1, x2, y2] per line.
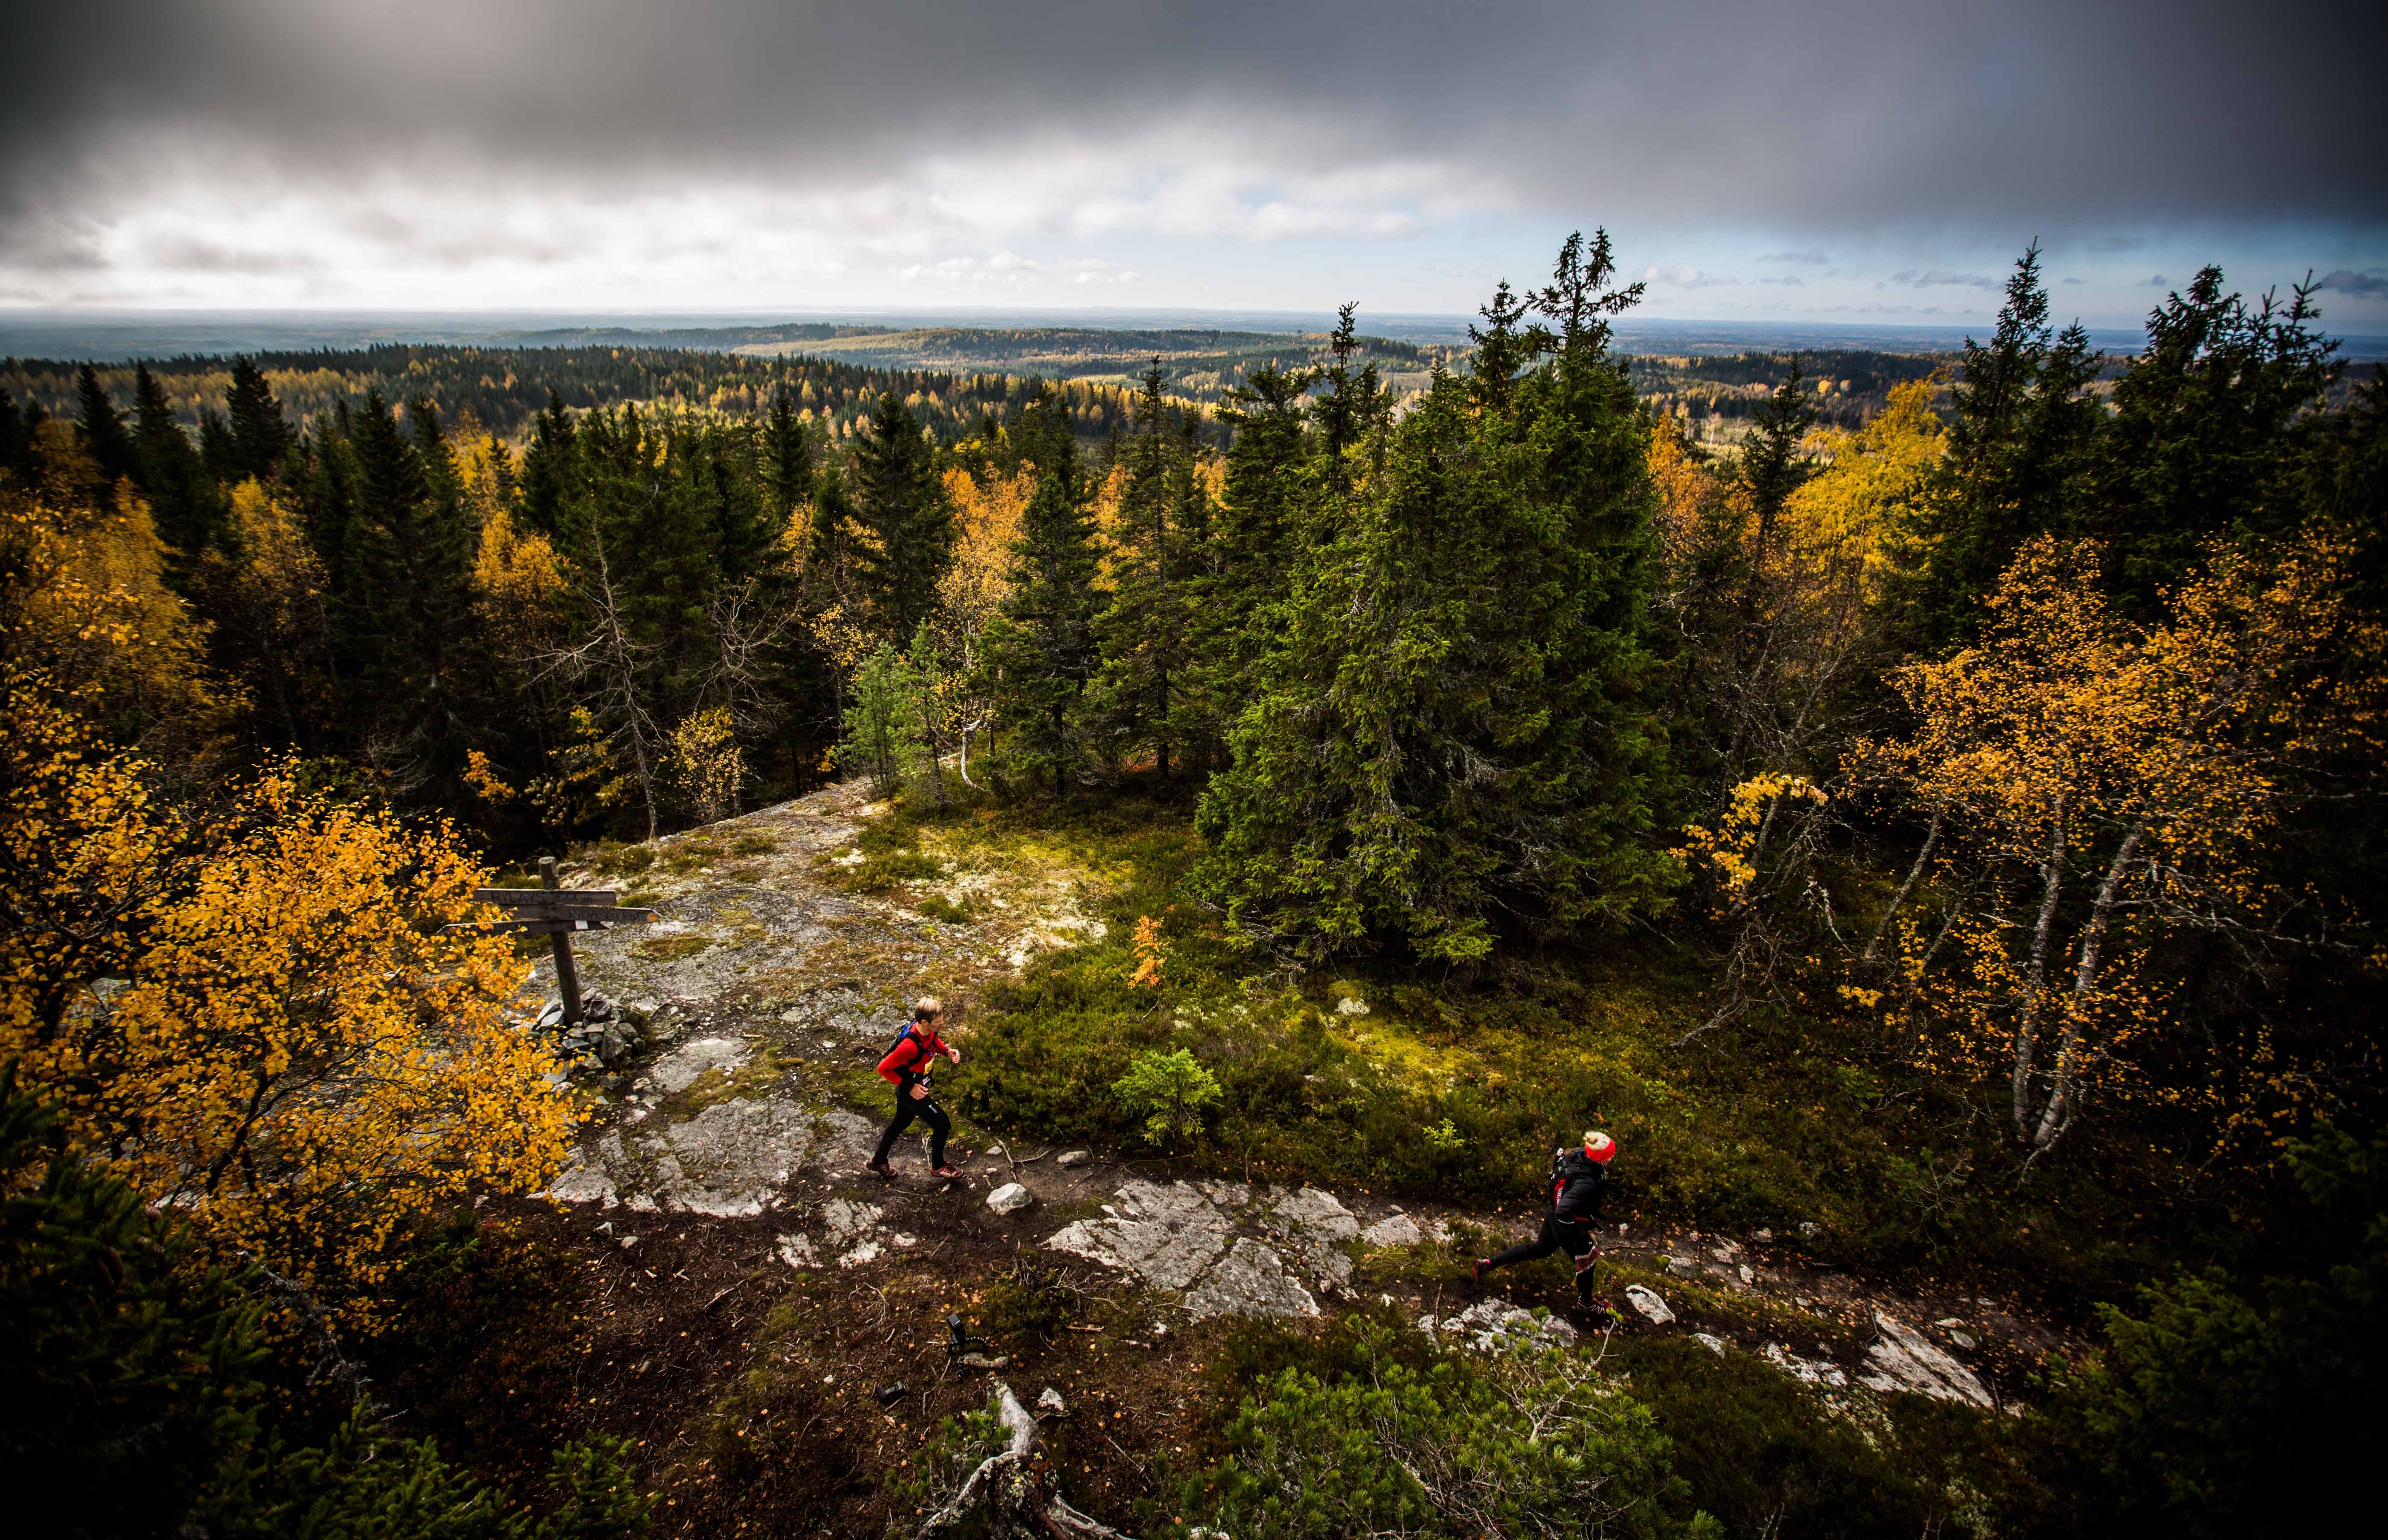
[984, 397, 1101, 795]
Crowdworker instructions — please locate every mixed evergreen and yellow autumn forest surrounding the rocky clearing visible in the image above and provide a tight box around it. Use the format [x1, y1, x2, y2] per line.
[0, 234, 2388, 1535]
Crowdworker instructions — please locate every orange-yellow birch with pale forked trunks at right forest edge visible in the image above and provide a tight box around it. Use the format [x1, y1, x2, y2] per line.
[1853, 537, 2379, 1161]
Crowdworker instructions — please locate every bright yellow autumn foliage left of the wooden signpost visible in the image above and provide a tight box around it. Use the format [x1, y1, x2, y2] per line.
[0, 666, 576, 1301]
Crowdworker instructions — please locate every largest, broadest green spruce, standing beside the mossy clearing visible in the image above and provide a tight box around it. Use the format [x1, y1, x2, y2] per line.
[1199, 248, 1671, 962]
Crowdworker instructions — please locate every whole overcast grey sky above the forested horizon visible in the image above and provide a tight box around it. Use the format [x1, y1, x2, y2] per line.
[0, 0, 2388, 332]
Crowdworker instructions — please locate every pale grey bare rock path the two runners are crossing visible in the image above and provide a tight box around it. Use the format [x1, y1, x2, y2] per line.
[538, 785, 2054, 1406]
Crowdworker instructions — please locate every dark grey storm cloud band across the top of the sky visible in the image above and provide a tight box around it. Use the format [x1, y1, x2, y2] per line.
[0, 0, 2388, 236]
